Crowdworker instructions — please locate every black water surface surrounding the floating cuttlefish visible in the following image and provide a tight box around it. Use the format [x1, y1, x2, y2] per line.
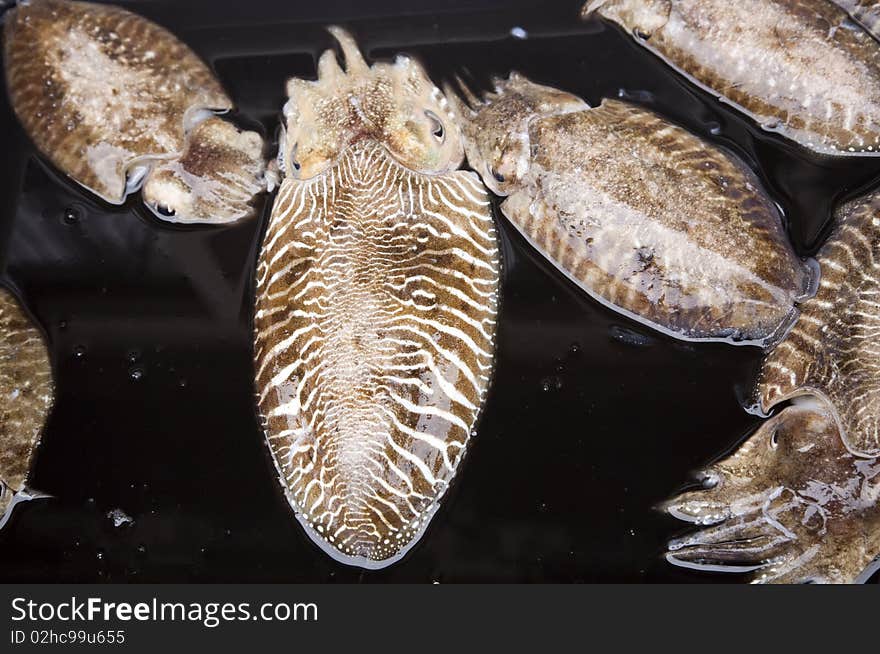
[0, 0, 880, 582]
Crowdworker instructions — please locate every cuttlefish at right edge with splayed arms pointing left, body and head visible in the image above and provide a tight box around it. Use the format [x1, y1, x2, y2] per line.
[669, 192, 880, 582]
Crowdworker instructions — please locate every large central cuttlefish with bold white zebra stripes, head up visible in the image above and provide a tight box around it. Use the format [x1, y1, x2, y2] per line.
[254, 28, 500, 568]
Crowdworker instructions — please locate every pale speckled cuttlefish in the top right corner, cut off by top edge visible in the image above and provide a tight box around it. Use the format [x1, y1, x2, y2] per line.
[583, 0, 880, 155]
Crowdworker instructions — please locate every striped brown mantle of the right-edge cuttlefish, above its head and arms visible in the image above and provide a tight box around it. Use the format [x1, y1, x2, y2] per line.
[758, 192, 880, 456]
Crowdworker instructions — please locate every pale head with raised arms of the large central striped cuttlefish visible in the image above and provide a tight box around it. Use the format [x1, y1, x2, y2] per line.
[279, 27, 464, 179]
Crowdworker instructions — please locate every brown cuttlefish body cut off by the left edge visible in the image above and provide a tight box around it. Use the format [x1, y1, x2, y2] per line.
[0, 288, 53, 517]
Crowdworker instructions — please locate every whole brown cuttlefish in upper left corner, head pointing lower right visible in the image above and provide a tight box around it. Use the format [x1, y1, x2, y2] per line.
[3, 0, 264, 222]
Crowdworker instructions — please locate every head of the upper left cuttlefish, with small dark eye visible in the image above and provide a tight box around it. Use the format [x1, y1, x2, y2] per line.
[142, 118, 266, 223]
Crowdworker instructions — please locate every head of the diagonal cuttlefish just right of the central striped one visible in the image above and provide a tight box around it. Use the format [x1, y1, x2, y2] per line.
[445, 73, 589, 195]
